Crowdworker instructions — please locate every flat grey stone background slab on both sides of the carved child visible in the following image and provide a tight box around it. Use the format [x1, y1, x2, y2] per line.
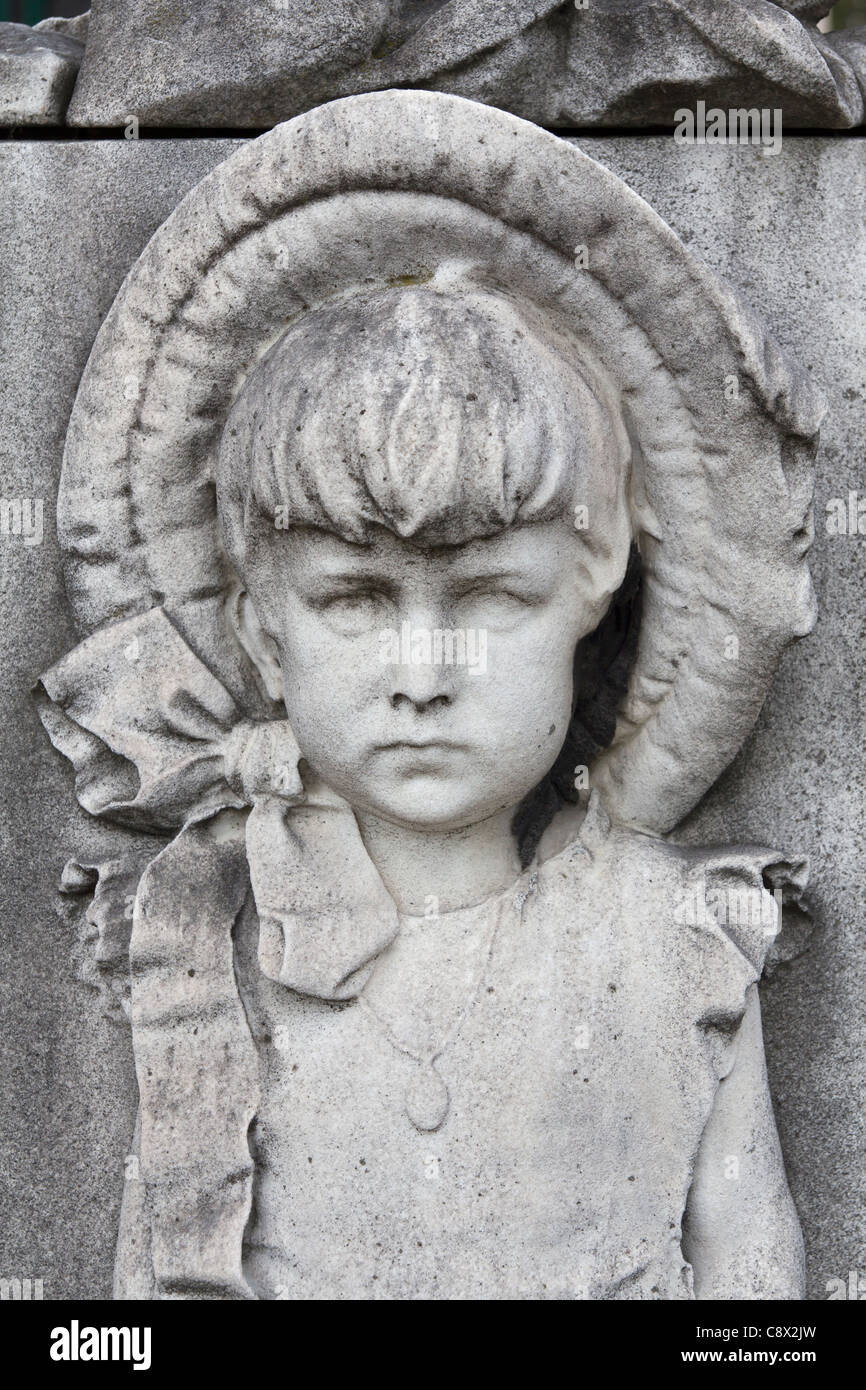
[0, 136, 866, 1298]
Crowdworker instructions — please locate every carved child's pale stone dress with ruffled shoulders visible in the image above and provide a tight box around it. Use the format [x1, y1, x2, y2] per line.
[115, 798, 800, 1300]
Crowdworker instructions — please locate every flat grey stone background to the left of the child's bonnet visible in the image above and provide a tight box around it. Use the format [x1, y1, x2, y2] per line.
[0, 132, 244, 1300]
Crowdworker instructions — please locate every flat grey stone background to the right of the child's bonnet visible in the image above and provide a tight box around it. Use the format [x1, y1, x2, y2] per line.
[581, 139, 866, 1298]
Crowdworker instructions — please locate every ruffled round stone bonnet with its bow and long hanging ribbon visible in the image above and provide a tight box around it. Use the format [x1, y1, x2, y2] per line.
[38, 90, 822, 1297]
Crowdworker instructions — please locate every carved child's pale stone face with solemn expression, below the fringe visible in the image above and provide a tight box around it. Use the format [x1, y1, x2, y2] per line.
[247, 520, 603, 828]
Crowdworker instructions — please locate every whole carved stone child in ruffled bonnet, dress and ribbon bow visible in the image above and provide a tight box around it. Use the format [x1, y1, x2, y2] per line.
[16, 92, 823, 1300]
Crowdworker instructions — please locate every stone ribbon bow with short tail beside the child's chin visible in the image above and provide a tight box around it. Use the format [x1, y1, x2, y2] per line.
[36, 607, 399, 999]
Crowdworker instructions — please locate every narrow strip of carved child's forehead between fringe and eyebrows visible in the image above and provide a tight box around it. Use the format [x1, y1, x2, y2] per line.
[277, 518, 578, 577]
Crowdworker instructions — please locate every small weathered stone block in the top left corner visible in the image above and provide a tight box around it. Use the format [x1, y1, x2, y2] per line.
[0, 24, 85, 125]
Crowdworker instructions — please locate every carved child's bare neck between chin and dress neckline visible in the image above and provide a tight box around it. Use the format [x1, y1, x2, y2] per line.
[356, 809, 521, 917]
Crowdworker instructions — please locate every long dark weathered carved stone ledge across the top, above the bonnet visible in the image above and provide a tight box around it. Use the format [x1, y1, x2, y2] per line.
[62, 0, 866, 128]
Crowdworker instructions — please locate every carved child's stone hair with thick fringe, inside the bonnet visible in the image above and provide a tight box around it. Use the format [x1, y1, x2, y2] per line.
[217, 284, 639, 862]
